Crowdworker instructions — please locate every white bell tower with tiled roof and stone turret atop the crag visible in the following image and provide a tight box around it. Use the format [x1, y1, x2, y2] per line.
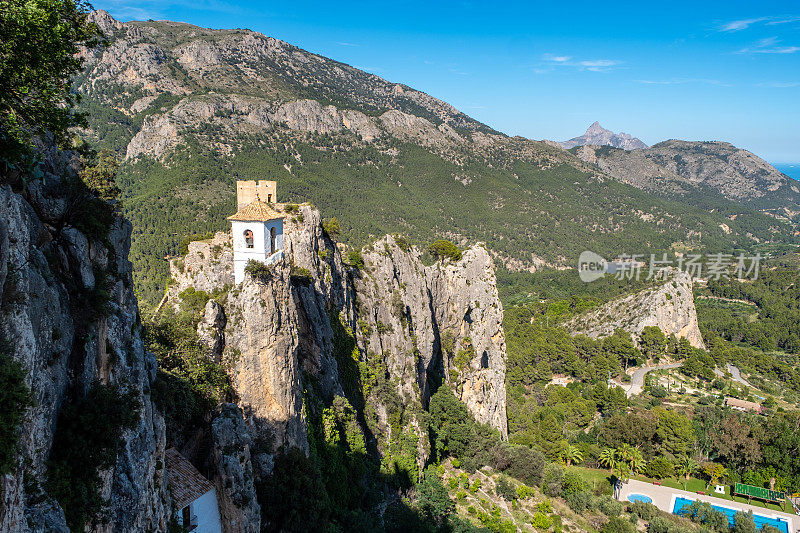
[228, 181, 283, 284]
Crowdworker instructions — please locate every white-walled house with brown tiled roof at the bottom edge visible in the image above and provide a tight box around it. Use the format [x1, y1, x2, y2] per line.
[164, 448, 222, 533]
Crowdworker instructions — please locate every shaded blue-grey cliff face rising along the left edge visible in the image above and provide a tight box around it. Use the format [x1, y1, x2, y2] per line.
[0, 152, 168, 531]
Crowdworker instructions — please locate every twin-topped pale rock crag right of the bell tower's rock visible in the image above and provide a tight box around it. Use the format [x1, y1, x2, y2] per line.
[355, 236, 507, 437]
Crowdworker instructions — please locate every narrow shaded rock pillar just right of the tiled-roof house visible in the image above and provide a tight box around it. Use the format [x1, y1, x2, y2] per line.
[211, 404, 260, 533]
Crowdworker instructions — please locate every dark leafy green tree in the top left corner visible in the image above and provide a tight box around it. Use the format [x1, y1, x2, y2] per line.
[0, 0, 100, 168]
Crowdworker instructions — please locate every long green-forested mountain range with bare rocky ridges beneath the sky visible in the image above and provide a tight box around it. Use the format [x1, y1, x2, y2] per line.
[74, 11, 800, 305]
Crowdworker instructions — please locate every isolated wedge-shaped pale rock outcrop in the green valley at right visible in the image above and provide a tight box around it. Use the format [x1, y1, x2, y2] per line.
[565, 272, 705, 349]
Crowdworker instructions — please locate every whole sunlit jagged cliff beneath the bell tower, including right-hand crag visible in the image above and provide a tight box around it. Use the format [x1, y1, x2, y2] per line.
[170, 205, 507, 462]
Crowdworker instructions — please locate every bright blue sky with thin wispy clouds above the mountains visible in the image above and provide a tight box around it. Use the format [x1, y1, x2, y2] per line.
[94, 0, 800, 163]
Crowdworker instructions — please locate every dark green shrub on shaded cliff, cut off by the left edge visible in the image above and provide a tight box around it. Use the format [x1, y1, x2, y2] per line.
[0, 352, 33, 475]
